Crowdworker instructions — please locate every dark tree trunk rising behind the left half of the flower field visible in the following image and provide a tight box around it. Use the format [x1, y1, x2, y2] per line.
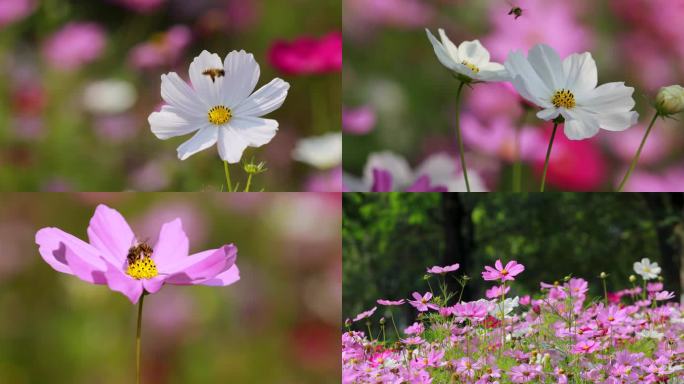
[442, 193, 475, 300]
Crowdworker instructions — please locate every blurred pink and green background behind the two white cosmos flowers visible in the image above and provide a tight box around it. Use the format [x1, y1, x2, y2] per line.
[343, 0, 684, 191]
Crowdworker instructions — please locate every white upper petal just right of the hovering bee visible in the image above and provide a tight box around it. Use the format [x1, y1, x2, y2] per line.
[222, 51, 261, 109]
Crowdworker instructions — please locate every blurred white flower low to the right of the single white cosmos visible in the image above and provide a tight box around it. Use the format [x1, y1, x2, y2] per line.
[292, 132, 342, 169]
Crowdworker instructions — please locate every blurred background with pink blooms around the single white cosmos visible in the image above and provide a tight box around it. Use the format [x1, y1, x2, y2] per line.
[0, 0, 342, 191]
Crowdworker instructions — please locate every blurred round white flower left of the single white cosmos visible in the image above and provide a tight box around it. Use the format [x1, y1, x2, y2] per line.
[83, 79, 138, 114]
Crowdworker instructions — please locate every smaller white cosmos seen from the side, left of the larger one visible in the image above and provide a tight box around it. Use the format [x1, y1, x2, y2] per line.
[425, 28, 508, 81]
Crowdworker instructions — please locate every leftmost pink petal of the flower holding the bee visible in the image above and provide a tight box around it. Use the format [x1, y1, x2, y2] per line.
[36, 228, 106, 282]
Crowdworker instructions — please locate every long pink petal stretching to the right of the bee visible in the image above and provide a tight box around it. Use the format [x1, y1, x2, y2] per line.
[160, 244, 237, 285]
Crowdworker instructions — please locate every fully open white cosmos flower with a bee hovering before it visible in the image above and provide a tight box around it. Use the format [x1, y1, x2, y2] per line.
[148, 51, 290, 163]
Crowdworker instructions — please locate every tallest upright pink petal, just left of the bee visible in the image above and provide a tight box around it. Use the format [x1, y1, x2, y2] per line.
[88, 204, 135, 266]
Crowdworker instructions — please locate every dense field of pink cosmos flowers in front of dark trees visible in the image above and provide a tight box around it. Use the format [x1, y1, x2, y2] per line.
[342, 258, 684, 384]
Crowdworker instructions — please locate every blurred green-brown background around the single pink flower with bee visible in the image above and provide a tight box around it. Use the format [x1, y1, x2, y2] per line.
[0, 193, 342, 384]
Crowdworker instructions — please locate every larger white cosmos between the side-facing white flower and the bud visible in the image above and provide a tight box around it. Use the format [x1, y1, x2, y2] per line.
[504, 44, 639, 140]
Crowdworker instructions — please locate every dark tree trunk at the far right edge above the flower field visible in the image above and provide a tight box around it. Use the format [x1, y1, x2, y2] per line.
[643, 193, 684, 294]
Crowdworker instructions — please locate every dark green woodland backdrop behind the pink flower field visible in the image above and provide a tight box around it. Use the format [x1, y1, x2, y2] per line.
[342, 192, 684, 329]
